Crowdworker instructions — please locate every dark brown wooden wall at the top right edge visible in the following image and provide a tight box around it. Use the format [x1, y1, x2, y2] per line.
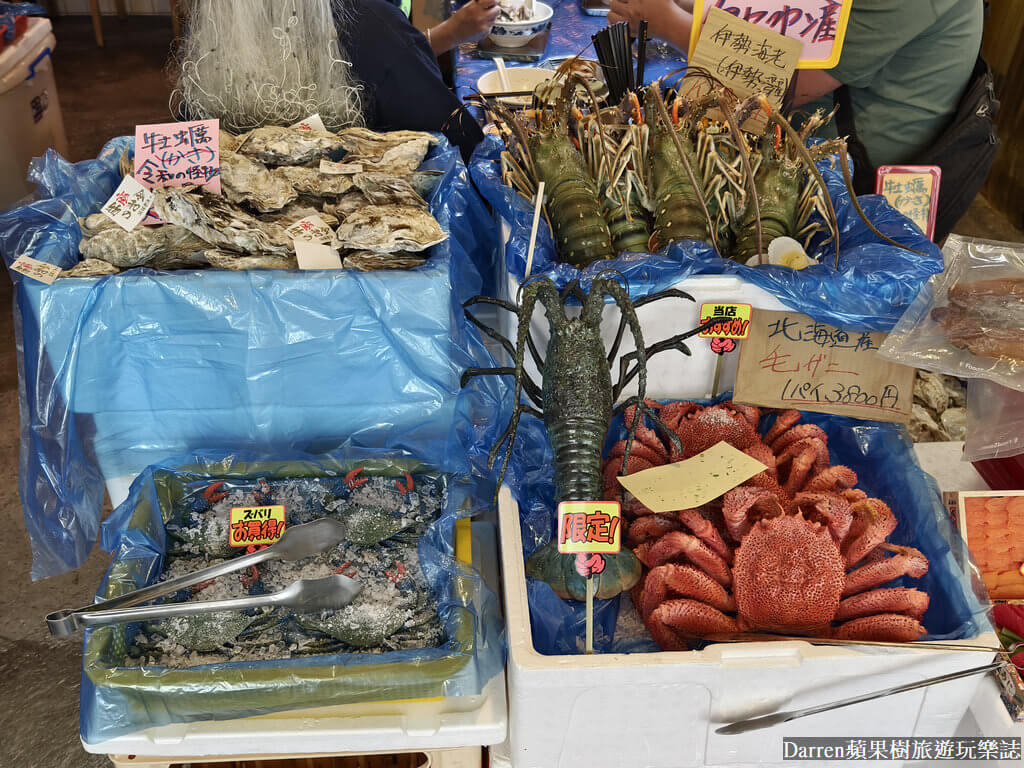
[982, 0, 1024, 228]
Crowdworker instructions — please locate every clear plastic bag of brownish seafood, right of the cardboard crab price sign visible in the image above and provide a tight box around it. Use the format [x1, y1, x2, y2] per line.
[879, 234, 1024, 391]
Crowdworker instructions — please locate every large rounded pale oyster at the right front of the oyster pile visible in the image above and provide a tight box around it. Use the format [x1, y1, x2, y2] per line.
[338, 205, 447, 253]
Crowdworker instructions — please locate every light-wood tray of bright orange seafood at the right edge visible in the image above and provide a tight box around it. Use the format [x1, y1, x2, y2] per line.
[957, 490, 1024, 600]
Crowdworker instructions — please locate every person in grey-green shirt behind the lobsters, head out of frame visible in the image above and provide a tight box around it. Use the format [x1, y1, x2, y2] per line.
[608, 0, 983, 166]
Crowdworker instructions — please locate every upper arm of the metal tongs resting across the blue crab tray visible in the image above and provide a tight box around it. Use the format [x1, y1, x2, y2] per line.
[46, 517, 355, 637]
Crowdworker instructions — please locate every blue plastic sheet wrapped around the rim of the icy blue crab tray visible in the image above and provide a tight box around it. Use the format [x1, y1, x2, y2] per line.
[81, 449, 505, 743]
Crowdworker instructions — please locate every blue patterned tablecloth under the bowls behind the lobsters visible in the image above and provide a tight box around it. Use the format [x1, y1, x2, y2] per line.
[455, 0, 686, 98]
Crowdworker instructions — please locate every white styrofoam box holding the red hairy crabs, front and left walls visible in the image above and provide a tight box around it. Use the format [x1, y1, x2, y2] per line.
[499, 487, 996, 768]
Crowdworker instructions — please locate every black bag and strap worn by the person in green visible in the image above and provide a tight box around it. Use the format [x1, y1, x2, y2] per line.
[834, 55, 999, 243]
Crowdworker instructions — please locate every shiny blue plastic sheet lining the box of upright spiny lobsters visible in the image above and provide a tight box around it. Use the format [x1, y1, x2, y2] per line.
[470, 136, 942, 331]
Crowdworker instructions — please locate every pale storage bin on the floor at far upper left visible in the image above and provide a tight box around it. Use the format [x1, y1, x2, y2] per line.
[0, 17, 68, 210]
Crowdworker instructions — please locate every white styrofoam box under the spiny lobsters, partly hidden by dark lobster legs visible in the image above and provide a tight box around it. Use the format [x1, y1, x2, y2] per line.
[499, 272, 790, 399]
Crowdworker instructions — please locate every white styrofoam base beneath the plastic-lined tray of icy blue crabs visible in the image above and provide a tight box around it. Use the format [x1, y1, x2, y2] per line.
[82, 523, 507, 768]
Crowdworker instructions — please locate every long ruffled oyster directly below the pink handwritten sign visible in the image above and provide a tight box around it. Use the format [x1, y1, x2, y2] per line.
[153, 187, 293, 256]
